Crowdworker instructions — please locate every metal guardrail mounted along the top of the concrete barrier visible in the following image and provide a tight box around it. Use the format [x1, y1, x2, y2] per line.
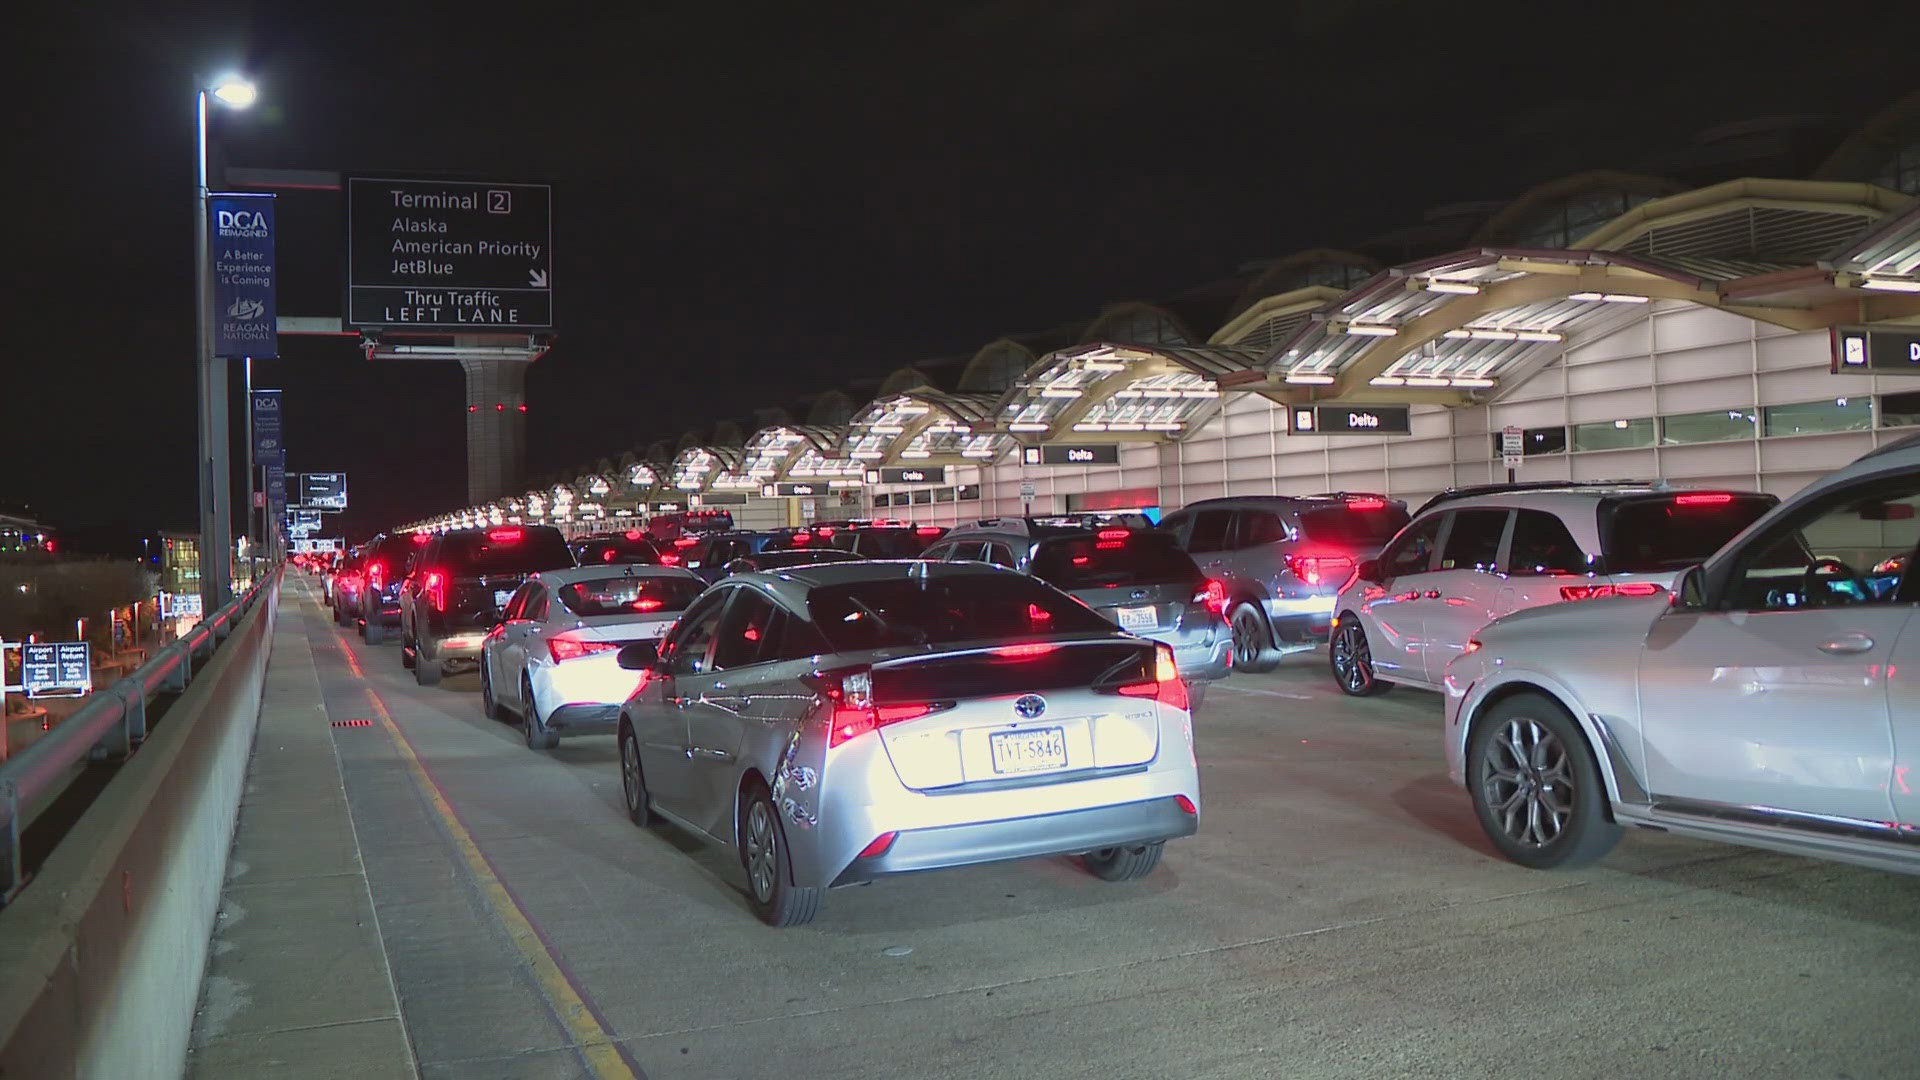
[0, 569, 280, 905]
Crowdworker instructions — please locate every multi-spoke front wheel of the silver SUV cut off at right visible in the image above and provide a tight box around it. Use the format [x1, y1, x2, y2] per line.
[1467, 694, 1622, 871]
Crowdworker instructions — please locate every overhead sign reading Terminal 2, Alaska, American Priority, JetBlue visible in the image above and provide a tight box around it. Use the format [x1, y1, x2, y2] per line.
[346, 177, 553, 331]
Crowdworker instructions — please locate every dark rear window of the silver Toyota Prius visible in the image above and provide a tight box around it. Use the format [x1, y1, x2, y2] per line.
[806, 573, 1114, 651]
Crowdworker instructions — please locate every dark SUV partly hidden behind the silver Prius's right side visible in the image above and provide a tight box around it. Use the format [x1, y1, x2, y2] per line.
[922, 517, 1233, 711]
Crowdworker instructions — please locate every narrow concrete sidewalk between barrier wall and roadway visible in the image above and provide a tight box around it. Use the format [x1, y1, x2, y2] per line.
[186, 582, 417, 1080]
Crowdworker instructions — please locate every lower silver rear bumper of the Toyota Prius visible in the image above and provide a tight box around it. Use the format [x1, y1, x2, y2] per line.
[831, 796, 1200, 886]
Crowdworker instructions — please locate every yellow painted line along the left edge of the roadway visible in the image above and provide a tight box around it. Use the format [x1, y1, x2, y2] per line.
[349, 651, 641, 1080]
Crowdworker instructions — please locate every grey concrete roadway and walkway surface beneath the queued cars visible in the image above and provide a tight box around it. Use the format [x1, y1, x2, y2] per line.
[192, 578, 1920, 1080]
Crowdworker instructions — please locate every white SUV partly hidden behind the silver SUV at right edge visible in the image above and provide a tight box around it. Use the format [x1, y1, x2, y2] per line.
[1327, 480, 1780, 696]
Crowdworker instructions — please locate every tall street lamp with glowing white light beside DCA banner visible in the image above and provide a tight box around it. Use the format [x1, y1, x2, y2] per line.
[194, 77, 259, 615]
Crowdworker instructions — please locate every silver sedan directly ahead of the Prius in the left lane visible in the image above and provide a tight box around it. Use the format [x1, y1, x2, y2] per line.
[480, 563, 707, 749]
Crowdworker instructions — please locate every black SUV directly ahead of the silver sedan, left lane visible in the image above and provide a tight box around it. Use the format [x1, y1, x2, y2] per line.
[399, 525, 574, 686]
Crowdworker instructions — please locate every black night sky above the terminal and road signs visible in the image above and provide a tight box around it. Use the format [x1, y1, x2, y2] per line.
[15, 0, 1920, 548]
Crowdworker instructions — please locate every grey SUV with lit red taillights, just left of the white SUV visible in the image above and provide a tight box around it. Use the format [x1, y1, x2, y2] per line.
[1160, 492, 1407, 671]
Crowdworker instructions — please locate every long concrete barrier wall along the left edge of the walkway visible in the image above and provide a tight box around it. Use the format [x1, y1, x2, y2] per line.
[0, 580, 278, 1080]
